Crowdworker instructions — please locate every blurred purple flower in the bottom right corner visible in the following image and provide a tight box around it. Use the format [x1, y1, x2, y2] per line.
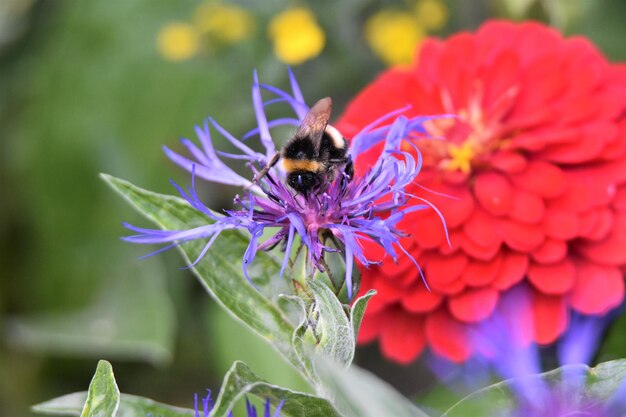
[431, 285, 626, 417]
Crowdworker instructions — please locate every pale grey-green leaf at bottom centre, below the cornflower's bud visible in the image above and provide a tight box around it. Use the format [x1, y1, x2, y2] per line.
[315, 358, 428, 417]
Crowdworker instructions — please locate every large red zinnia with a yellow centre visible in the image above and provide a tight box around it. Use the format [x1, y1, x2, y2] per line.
[337, 21, 626, 363]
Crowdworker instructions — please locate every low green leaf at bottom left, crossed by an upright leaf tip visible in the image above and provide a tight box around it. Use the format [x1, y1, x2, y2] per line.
[32, 391, 194, 417]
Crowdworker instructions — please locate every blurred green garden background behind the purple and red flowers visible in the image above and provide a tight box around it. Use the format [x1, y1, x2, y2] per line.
[0, 0, 626, 416]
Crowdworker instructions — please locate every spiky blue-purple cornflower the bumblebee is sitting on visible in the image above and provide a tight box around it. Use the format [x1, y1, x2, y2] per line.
[125, 71, 445, 298]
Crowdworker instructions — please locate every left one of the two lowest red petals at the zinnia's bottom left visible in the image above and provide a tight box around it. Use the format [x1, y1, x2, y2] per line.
[380, 310, 426, 364]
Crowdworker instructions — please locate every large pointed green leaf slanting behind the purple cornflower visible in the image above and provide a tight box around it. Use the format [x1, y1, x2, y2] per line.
[102, 174, 300, 369]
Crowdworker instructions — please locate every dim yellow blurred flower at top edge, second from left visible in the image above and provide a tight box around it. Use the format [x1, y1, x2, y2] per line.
[193, 3, 254, 43]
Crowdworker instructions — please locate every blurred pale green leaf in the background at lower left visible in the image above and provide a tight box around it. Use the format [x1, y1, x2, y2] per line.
[7, 260, 175, 364]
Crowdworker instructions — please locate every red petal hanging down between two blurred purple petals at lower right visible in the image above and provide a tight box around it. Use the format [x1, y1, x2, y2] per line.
[532, 292, 568, 344]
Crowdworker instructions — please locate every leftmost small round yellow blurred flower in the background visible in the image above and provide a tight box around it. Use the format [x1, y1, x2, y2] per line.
[157, 22, 200, 61]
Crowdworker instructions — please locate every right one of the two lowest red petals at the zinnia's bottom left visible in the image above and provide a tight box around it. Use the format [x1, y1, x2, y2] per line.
[424, 309, 472, 362]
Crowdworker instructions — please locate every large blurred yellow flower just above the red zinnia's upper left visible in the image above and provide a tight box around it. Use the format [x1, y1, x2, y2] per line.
[365, 10, 424, 65]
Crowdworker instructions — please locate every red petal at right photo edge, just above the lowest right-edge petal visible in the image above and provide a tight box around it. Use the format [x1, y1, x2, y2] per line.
[576, 213, 626, 265]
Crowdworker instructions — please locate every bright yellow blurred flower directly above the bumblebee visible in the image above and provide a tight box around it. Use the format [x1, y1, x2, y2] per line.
[268, 7, 326, 65]
